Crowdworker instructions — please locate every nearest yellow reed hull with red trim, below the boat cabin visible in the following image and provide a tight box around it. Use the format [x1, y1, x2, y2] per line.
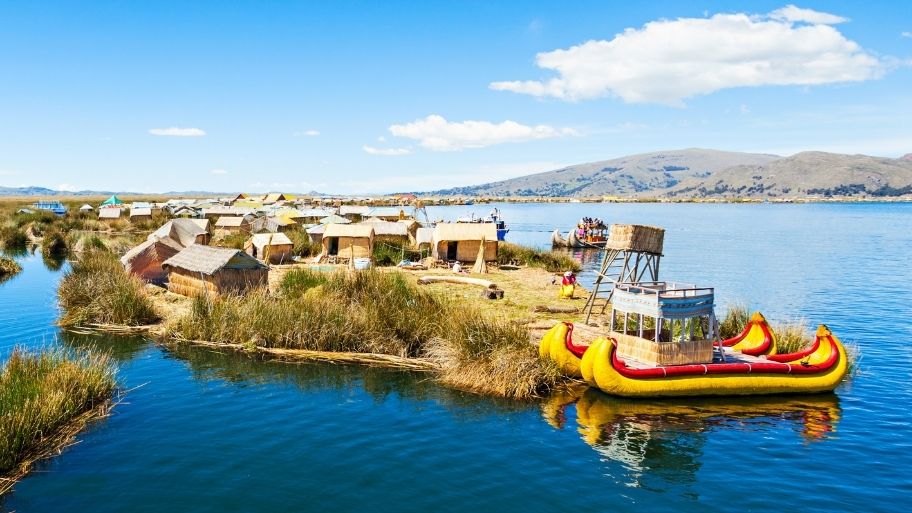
[580, 325, 848, 397]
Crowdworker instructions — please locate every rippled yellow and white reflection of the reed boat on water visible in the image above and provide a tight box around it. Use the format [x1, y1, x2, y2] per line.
[541, 388, 841, 490]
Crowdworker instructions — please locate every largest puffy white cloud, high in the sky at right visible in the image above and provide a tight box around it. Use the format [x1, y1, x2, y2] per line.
[490, 5, 887, 106]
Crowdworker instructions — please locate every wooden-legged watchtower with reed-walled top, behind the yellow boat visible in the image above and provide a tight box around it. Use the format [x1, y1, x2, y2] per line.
[584, 224, 665, 323]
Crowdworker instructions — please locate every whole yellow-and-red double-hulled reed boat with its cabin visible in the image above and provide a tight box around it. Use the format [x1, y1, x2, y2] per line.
[539, 282, 848, 397]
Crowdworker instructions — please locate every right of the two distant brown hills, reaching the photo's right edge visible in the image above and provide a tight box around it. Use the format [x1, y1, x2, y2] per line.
[665, 151, 912, 198]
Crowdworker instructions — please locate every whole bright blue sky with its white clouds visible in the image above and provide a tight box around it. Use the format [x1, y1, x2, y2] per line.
[0, 0, 912, 194]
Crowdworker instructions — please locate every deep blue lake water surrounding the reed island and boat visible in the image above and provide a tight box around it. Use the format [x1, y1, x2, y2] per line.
[0, 204, 912, 512]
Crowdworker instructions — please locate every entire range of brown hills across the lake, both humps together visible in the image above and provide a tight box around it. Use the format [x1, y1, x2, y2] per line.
[434, 148, 912, 199]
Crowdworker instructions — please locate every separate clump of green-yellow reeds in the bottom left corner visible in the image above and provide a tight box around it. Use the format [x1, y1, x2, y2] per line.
[0, 349, 116, 495]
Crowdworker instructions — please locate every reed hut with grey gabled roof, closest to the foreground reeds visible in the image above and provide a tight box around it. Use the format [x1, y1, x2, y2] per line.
[162, 244, 269, 297]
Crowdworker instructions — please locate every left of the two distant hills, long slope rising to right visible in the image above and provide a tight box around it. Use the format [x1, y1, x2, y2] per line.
[432, 148, 780, 197]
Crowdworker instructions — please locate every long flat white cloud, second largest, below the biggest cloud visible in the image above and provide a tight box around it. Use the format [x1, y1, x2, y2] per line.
[389, 114, 579, 151]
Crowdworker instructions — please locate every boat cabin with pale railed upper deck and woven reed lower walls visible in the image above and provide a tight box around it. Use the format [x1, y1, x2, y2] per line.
[609, 281, 716, 366]
